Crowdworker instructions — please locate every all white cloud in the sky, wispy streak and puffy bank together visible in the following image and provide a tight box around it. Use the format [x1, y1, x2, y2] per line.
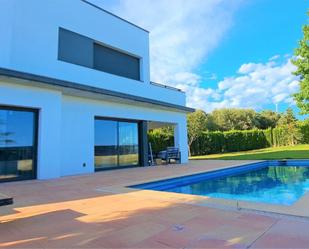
[88, 0, 298, 112]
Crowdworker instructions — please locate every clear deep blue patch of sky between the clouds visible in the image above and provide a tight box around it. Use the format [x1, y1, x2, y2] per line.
[200, 0, 309, 84]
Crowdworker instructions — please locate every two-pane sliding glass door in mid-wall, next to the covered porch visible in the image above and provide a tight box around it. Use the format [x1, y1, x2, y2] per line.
[95, 118, 139, 170]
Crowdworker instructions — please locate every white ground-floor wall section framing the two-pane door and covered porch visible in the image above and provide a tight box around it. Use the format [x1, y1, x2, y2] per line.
[61, 95, 188, 175]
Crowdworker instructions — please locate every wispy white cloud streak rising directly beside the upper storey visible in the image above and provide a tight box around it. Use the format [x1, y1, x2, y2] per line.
[92, 0, 244, 86]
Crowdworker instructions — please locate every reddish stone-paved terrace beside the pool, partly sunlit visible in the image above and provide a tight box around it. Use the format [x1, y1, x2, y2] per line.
[0, 161, 309, 248]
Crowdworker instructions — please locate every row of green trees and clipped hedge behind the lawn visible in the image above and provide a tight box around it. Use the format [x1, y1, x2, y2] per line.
[184, 108, 309, 154]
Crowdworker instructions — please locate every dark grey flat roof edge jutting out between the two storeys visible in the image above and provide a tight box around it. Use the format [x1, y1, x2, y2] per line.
[0, 67, 195, 112]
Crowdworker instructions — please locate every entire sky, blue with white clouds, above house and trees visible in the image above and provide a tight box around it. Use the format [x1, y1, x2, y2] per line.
[92, 0, 309, 115]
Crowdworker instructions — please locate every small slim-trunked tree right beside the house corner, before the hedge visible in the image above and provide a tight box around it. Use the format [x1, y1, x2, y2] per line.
[187, 110, 207, 155]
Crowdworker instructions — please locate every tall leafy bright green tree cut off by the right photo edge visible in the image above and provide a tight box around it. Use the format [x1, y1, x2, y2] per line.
[292, 17, 309, 114]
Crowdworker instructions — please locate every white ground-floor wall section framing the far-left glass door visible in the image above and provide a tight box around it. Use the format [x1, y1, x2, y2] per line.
[0, 81, 62, 179]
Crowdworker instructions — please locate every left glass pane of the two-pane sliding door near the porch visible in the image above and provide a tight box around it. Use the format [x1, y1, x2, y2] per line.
[95, 119, 118, 169]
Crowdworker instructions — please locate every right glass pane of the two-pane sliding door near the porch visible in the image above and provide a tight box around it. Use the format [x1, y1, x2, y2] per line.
[119, 122, 139, 166]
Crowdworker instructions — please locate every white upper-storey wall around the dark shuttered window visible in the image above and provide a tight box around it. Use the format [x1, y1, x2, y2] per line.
[0, 0, 185, 105]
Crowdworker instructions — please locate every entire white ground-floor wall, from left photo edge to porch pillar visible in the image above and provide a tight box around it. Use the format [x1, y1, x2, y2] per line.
[0, 80, 188, 179]
